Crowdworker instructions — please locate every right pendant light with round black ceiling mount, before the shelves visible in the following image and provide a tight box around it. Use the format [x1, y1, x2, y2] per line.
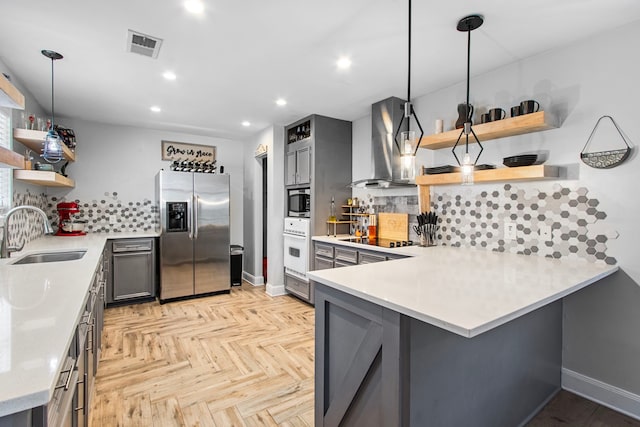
[451, 15, 484, 185]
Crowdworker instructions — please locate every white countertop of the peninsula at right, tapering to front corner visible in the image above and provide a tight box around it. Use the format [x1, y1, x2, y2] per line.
[308, 246, 618, 338]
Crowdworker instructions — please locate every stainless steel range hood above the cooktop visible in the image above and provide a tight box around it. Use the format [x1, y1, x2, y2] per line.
[351, 97, 415, 188]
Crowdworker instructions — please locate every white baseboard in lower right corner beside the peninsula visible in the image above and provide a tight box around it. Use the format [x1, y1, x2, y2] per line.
[562, 368, 640, 420]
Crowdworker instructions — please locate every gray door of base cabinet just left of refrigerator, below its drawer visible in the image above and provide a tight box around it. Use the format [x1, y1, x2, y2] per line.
[112, 252, 154, 301]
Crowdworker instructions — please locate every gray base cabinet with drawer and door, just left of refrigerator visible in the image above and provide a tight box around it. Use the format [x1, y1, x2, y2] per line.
[106, 238, 156, 303]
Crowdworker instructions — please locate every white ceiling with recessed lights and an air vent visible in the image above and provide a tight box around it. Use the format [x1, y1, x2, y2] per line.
[0, 0, 640, 138]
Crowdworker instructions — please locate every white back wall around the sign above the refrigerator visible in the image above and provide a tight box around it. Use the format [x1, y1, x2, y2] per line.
[47, 118, 244, 244]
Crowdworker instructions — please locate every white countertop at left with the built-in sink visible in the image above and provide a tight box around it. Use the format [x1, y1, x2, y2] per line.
[0, 232, 158, 417]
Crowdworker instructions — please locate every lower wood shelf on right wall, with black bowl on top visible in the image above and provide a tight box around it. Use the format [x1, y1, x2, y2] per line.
[416, 165, 560, 185]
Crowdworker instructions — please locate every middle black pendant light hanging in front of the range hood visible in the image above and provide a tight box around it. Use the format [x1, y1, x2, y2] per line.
[394, 0, 424, 181]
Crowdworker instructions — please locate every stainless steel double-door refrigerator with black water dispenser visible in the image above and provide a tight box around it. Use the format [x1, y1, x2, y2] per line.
[156, 171, 231, 302]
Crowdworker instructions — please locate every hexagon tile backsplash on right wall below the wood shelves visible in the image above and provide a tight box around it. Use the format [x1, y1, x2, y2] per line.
[363, 183, 618, 264]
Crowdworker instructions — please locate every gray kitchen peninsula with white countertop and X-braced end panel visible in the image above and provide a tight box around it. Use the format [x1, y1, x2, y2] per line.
[309, 246, 618, 427]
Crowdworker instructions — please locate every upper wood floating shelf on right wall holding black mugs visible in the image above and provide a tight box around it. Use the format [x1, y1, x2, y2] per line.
[420, 111, 558, 150]
